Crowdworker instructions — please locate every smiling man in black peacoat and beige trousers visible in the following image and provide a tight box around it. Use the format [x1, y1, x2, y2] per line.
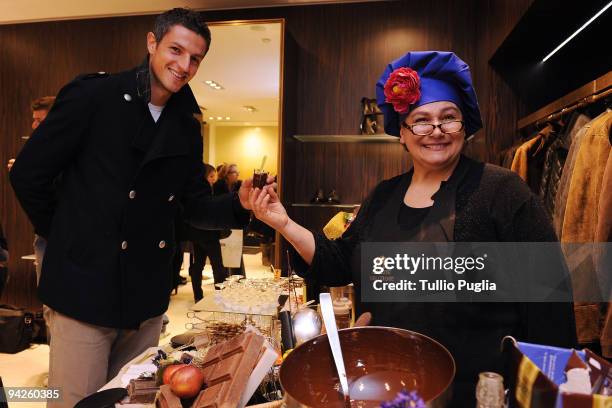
[10, 9, 251, 407]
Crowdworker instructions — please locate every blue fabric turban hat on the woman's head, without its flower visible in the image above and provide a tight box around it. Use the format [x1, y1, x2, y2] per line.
[376, 51, 482, 136]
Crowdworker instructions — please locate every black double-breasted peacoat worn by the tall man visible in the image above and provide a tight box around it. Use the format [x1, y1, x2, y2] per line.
[10, 63, 249, 328]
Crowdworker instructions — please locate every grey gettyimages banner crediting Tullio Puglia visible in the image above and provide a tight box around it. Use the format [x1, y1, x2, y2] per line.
[361, 242, 612, 302]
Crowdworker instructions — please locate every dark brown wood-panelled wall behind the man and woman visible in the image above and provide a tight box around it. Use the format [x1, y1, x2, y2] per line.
[0, 0, 530, 307]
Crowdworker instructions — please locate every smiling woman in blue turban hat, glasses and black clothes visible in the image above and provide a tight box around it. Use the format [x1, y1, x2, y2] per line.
[251, 51, 576, 407]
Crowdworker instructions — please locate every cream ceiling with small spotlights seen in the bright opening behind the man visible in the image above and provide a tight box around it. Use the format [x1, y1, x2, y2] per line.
[189, 22, 281, 124]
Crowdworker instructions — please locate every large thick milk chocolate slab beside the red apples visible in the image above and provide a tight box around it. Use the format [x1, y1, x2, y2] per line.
[193, 332, 264, 408]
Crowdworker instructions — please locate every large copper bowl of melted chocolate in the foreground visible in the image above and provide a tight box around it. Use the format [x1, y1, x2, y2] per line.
[280, 327, 455, 408]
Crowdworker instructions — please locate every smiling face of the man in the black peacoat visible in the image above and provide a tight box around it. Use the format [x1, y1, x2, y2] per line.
[147, 24, 208, 104]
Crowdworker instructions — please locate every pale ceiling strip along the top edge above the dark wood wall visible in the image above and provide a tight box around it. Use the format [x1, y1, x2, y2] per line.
[0, 0, 380, 24]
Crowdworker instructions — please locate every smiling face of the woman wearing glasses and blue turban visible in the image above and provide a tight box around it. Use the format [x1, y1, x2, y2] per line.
[400, 101, 465, 170]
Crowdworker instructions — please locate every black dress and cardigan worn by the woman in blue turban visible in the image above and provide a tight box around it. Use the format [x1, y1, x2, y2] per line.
[294, 156, 576, 407]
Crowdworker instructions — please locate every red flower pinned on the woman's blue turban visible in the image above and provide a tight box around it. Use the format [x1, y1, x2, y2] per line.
[385, 67, 421, 113]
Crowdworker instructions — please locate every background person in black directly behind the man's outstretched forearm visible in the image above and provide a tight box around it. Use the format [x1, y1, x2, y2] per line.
[186, 164, 227, 303]
